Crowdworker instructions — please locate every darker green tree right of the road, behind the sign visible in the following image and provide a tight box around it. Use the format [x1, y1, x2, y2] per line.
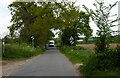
[62, 11, 92, 45]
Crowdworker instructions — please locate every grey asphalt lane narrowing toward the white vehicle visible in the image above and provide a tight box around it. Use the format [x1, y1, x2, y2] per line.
[10, 48, 78, 76]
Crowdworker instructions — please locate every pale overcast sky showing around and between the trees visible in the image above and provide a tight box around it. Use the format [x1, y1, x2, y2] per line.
[0, 0, 120, 37]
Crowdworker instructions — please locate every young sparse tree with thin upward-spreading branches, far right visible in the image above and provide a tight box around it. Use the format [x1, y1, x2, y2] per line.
[83, 0, 119, 53]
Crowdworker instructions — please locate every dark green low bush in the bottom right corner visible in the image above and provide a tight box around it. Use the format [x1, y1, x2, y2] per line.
[79, 49, 120, 76]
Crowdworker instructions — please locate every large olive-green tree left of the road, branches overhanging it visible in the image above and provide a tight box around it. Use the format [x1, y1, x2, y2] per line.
[8, 2, 79, 45]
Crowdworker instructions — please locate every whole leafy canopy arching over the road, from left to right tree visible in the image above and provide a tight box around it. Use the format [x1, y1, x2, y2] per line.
[8, 1, 92, 46]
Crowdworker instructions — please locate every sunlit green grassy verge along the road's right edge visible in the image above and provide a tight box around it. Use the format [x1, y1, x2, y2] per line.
[59, 46, 94, 63]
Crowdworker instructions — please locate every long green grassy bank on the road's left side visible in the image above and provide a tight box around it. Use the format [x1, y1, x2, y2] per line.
[2, 44, 45, 60]
